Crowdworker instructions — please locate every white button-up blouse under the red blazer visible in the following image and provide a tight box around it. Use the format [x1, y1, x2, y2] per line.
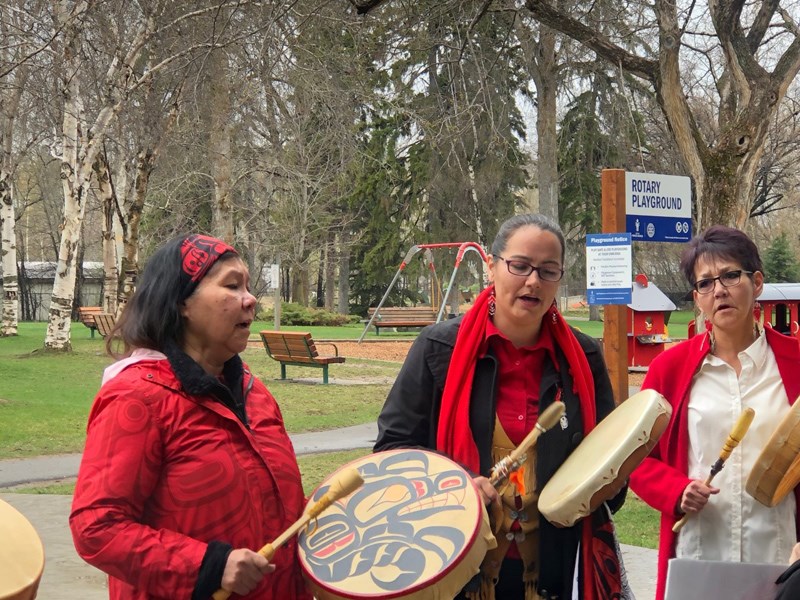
[676, 335, 796, 564]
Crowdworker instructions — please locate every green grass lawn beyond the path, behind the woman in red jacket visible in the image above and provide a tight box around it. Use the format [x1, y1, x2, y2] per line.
[0, 323, 400, 459]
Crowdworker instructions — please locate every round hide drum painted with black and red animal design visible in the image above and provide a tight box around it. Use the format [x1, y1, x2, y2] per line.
[299, 449, 497, 600]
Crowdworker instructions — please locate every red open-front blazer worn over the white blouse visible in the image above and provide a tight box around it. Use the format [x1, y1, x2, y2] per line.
[630, 328, 800, 600]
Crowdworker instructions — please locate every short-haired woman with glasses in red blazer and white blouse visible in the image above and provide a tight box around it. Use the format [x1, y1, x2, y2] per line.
[630, 225, 800, 600]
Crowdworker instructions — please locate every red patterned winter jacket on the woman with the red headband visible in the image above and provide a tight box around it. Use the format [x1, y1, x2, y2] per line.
[70, 360, 311, 600]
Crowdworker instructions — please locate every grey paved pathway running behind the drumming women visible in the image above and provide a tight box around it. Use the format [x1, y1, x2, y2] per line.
[0, 423, 656, 600]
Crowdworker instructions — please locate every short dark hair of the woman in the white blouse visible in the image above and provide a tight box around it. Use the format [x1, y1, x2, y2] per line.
[681, 225, 764, 286]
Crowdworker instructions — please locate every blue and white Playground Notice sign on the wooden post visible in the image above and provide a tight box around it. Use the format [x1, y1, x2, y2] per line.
[586, 233, 632, 304]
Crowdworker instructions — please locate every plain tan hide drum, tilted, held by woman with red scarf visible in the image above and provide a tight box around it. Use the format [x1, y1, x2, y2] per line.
[539, 390, 672, 527]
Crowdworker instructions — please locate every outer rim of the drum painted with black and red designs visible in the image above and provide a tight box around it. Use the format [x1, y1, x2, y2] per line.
[297, 447, 483, 600]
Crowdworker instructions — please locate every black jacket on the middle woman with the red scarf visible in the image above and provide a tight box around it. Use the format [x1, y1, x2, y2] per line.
[374, 318, 627, 598]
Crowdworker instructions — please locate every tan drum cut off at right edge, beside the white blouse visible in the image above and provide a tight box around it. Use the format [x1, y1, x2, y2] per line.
[745, 400, 800, 507]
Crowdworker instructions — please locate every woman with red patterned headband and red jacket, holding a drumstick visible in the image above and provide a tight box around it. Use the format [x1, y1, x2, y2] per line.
[70, 235, 311, 600]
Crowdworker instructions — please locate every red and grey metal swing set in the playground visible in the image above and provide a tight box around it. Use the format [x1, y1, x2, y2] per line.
[358, 242, 489, 343]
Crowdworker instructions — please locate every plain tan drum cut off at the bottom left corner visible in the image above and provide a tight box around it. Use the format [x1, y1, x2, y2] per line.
[0, 500, 44, 600]
